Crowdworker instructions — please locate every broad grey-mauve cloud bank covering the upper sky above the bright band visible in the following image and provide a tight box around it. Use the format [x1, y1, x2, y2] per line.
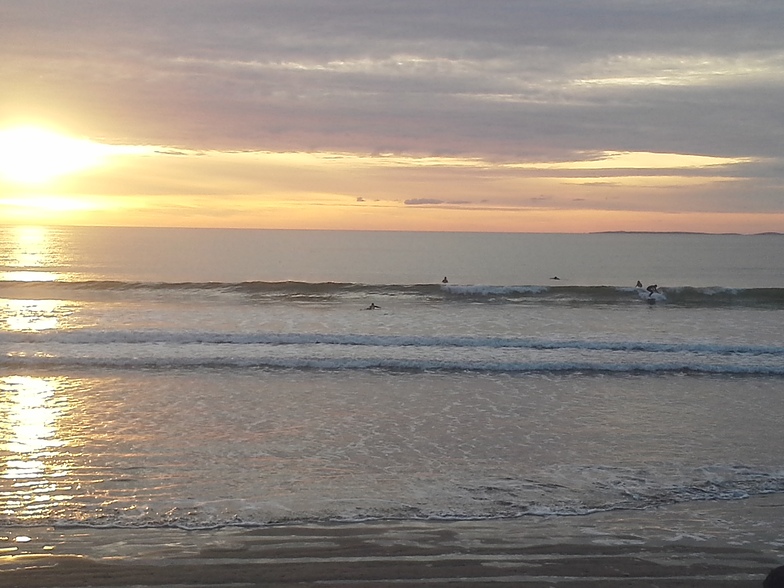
[6, 0, 784, 156]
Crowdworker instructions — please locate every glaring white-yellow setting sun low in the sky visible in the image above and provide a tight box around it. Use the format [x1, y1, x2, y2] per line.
[0, 126, 111, 184]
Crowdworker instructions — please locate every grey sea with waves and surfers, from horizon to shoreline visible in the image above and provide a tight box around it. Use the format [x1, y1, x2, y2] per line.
[0, 227, 784, 528]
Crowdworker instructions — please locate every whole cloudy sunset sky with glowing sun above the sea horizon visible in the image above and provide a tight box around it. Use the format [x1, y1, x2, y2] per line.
[0, 0, 784, 233]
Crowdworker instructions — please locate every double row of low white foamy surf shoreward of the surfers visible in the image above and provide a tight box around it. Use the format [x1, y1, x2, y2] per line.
[0, 330, 784, 376]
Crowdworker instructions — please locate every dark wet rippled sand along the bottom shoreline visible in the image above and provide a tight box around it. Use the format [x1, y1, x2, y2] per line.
[0, 495, 784, 588]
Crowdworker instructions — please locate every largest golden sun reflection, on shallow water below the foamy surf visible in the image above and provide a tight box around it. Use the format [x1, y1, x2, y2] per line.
[0, 376, 73, 520]
